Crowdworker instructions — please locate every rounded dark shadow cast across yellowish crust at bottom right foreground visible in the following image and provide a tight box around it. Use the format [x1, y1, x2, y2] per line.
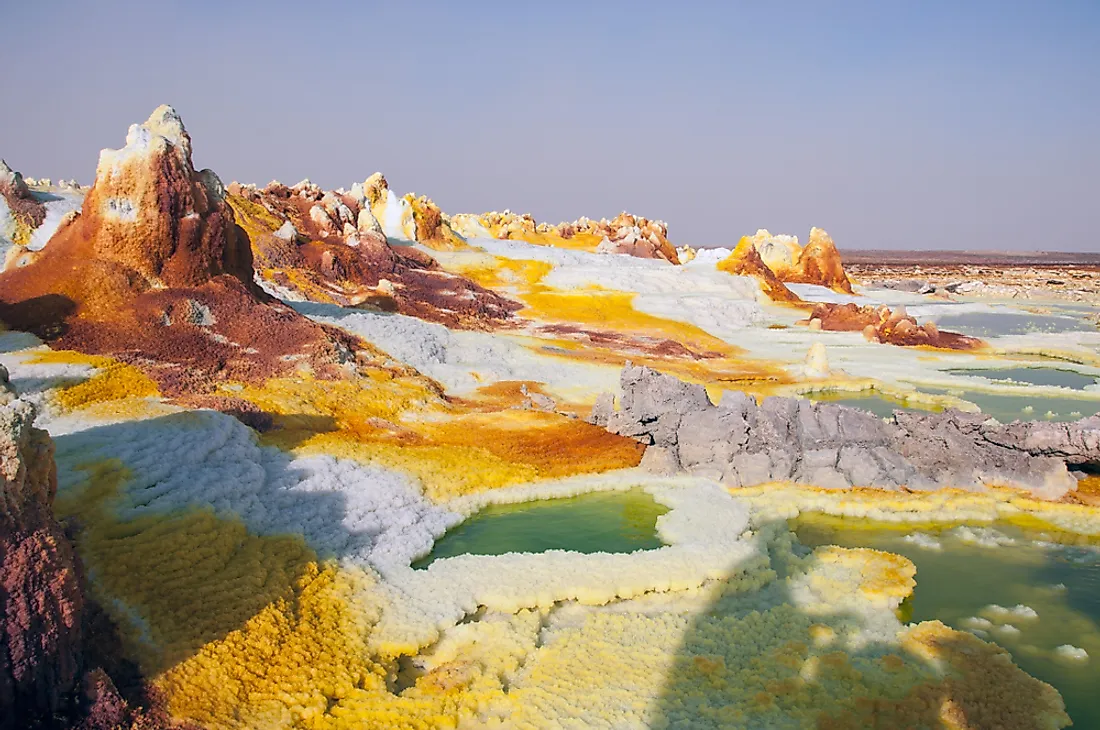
[650, 524, 1060, 730]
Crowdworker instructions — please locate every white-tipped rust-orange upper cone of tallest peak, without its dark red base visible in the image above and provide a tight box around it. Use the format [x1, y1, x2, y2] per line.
[0, 107, 254, 317]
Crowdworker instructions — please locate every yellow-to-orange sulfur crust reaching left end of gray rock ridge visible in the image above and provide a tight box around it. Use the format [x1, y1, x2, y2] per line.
[235, 374, 642, 501]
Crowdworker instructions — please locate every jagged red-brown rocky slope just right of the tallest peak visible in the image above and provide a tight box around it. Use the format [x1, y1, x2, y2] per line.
[229, 174, 520, 329]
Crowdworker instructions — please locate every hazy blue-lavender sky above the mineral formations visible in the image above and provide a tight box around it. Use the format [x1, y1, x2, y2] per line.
[0, 0, 1100, 251]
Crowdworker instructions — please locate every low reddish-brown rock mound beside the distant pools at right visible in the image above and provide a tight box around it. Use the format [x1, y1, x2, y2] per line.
[801, 302, 985, 350]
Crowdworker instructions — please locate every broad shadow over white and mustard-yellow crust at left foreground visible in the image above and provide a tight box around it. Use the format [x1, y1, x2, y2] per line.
[55, 412, 385, 676]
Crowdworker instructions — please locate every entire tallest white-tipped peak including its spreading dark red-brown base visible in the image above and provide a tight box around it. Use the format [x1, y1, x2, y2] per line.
[0, 107, 369, 395]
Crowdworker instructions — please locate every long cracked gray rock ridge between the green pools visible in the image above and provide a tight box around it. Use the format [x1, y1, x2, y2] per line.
[591, 365, 1100, 499]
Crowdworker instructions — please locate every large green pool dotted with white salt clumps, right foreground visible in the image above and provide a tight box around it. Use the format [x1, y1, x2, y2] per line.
[792, 519, 1100, 728]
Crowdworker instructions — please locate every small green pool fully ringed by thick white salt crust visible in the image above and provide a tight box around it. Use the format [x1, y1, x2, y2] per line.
[413, 489, 669, 568]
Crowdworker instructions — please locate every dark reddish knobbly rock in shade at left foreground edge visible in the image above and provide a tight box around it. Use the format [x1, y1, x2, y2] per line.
[0, 384, 172, 730]
